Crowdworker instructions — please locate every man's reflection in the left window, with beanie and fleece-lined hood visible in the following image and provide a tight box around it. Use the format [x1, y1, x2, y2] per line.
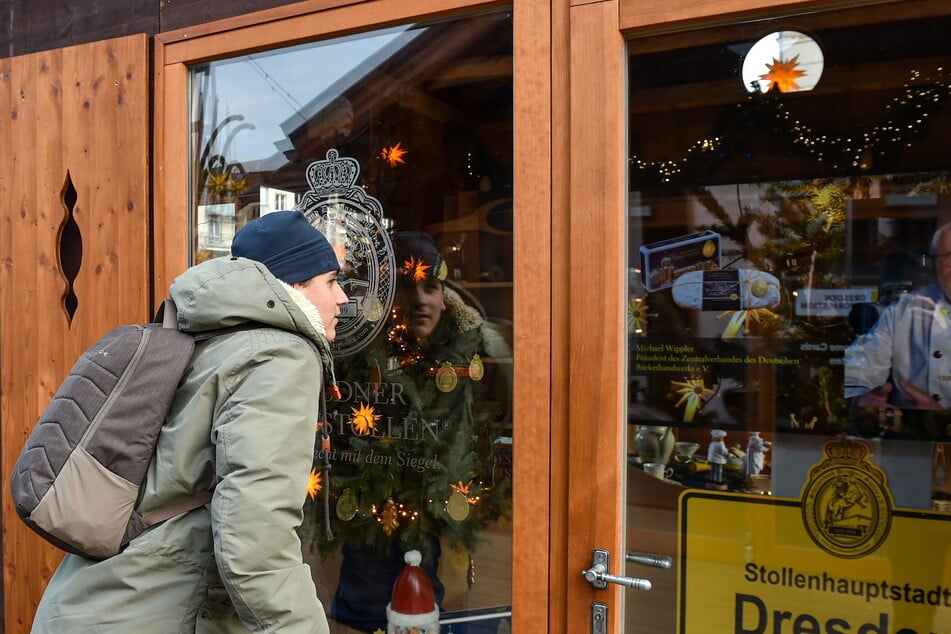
[318, 232, 512, 632]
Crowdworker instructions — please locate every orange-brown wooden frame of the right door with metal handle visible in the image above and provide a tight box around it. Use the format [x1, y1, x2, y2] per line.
[553, 0, 884, 633]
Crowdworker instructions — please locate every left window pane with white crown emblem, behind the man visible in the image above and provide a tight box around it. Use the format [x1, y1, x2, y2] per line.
[190, 12, 513, 633]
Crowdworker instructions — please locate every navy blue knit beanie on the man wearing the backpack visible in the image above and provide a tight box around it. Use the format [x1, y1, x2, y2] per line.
[231, 211, 340, 284]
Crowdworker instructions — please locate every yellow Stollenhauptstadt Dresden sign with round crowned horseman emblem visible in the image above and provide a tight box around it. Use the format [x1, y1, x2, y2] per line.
[677, 441, 951, 634]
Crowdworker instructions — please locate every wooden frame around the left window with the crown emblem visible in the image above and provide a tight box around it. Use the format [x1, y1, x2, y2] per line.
[153, 0, 568, 632]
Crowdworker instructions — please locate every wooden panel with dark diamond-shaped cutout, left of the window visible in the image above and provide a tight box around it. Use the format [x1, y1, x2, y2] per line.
[0, 35, 152, 634]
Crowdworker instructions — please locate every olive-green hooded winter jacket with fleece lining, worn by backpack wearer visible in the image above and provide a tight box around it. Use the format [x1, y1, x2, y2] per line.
[33, 258, 332, 634]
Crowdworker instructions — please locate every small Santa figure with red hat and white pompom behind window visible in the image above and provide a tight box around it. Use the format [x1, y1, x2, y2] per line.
[386, 550, 439, 634]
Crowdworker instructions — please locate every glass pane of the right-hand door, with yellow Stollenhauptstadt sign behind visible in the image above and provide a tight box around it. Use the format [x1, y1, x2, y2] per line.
[625, 2, 951, 634]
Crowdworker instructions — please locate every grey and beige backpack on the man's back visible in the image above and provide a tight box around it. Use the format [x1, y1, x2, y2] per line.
[10, 300, 247, 559]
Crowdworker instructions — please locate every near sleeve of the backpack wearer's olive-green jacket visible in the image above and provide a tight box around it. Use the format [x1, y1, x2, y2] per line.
[211, 330, 329, 634]
